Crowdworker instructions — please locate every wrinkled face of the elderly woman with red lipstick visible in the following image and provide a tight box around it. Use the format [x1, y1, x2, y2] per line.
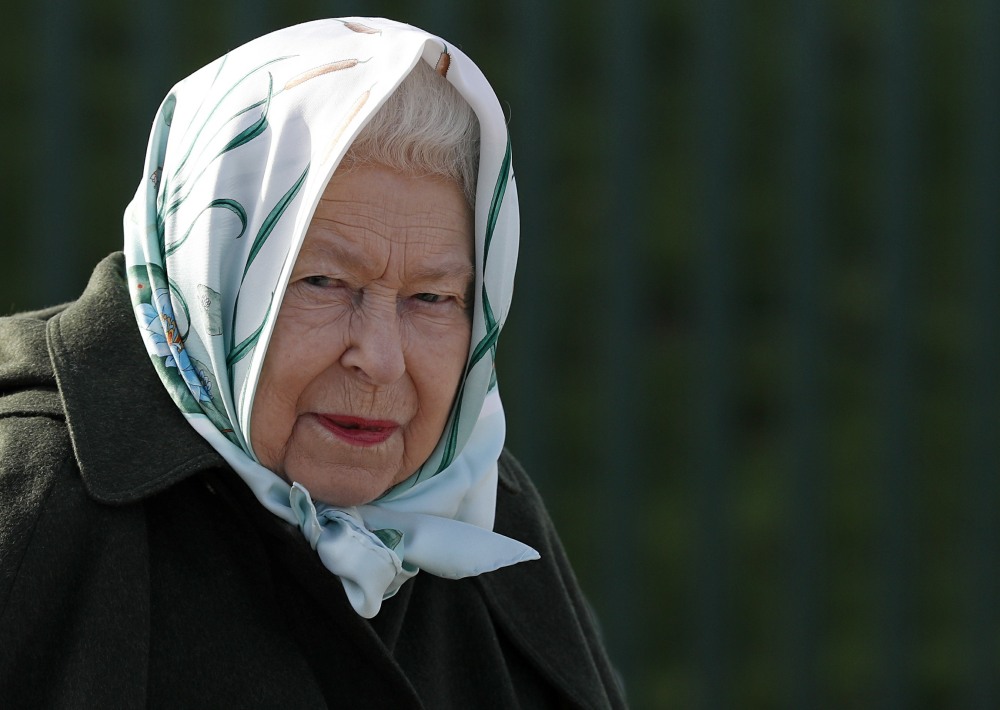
[250, 167, 475, 506]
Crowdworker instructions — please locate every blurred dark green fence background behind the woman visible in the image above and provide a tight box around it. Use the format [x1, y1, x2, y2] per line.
[0, 0, 1000, 708]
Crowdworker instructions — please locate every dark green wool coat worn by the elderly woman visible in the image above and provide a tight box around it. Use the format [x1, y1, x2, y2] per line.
[0, 254, 624, 708]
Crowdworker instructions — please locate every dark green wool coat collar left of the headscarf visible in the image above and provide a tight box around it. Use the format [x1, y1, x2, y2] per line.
[46, 253, 224, 504]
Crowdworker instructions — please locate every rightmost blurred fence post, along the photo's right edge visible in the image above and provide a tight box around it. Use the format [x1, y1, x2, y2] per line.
[963, 0, 1000, 710]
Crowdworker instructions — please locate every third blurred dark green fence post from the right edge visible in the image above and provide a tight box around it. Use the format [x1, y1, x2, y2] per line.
[788, 0, 830, 708]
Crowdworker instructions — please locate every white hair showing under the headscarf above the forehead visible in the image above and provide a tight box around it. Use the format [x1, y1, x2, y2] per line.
[341, 61, 479, 208]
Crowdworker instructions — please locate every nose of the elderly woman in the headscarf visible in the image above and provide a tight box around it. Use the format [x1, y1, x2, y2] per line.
[341, 304, 406, 385]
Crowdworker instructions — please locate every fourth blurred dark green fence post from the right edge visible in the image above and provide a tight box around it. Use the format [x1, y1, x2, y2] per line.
[691, 0, 738, 708]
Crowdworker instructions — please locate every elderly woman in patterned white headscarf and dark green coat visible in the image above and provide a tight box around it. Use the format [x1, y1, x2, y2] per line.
[0, 18, 623, 708]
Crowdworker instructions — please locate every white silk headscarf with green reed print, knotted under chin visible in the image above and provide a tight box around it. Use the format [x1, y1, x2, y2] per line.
[124, 18, 538, 618]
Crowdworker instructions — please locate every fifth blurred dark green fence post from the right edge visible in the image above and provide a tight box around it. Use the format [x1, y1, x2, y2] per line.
[594, 0, 647, 700]
